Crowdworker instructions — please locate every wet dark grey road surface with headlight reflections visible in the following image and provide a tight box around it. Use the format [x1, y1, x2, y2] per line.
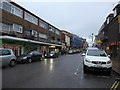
[3, 54, 119, 88]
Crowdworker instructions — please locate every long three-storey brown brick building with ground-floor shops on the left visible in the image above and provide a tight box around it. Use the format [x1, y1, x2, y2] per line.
[0, 0, 62, 56]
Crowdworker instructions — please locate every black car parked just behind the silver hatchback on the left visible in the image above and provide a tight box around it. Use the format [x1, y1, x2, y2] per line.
[17, 51, 42, 63]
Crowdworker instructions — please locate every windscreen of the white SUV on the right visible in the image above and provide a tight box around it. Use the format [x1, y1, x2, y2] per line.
[87, 50, 106, 57]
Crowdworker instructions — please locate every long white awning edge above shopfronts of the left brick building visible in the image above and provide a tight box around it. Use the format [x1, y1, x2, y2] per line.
[0, 36, 62, 47]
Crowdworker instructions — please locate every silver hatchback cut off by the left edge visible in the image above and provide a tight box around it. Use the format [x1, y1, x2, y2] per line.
[0, 48, 16, 67]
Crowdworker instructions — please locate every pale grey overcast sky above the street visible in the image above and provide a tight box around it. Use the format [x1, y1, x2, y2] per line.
[11, 0, 117, 43]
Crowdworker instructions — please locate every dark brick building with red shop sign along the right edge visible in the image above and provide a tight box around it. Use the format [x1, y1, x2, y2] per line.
[98, 4, 120, 73]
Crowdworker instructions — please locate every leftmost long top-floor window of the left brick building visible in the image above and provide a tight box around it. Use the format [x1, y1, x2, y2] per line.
[0, 1, 23, 18]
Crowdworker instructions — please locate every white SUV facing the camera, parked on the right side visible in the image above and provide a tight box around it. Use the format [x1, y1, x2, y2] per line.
[82, 48, 112, 74]
